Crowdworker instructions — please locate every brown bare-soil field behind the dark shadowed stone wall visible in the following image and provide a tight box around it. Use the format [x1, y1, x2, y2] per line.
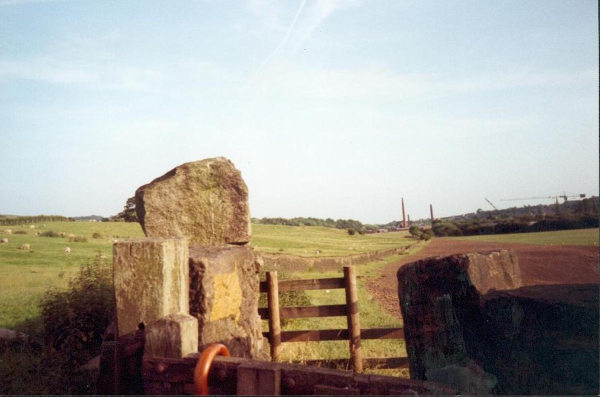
[367, 238, 598, 317]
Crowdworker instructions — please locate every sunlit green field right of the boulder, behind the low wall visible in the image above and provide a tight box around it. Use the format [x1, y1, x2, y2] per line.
[252, 224, 415, 256]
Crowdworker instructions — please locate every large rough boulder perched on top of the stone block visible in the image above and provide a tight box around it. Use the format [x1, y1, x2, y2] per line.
[135, 157, 251, 245]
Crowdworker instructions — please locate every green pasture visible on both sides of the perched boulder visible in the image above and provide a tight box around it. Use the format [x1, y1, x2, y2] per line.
[0, 222, 414, 328]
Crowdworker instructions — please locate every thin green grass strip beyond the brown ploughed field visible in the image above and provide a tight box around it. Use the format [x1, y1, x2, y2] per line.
[452, 229, 599, 246]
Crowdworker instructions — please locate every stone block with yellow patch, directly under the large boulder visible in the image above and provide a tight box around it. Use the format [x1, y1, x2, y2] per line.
[190, 246, 269, 360]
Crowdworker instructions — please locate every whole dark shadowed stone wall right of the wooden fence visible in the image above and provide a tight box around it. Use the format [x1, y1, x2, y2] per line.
[398, 251, 598, 395]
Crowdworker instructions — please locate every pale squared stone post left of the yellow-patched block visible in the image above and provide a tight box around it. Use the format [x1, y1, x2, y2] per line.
[113, 238, 189, 335]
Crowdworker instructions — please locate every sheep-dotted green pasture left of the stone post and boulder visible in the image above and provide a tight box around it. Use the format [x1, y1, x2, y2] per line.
[0, 222, 143, 328]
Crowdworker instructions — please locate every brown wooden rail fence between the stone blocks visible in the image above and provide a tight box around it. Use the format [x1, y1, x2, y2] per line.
[258, 266, 408, 372]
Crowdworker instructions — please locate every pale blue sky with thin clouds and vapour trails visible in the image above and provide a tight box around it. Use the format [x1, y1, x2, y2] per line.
[0, 0, 600, 224]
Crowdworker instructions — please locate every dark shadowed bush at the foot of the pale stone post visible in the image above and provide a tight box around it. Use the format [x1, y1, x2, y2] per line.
[0, 255, 114, 395]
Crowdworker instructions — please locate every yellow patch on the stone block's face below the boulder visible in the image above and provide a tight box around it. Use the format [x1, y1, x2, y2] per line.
[210, 269, 242, 322]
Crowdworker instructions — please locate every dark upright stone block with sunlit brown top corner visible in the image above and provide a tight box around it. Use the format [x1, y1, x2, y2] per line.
[398, 251, 522, 386]
